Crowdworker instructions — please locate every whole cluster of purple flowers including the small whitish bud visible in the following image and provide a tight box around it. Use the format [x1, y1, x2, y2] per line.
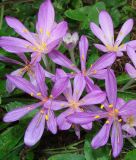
[0, 0, 136, 157]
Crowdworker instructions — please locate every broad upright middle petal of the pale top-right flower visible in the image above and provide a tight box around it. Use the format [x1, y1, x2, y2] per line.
[99, 11, 114, 45]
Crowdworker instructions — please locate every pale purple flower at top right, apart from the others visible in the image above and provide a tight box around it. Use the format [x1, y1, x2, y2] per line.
[90, 11, 136, 57]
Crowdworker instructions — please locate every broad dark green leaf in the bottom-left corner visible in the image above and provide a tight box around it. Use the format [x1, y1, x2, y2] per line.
[0, 125, 24, 159]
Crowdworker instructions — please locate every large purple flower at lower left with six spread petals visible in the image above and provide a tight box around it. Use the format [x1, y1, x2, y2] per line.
[3, 64, 68, 146]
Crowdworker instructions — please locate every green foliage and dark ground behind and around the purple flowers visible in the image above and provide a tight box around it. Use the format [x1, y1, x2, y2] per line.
[0, 0, 136, 160]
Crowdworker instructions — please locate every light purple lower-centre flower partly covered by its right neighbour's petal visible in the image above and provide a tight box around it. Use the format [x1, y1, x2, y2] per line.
[57, 71, 106, 138]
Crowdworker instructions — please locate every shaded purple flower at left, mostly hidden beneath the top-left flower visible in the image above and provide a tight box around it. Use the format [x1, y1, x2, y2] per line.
[0, 53, 54, 93]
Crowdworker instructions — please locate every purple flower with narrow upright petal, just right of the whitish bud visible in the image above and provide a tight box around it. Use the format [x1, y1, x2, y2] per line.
[49, 36, 116, 89]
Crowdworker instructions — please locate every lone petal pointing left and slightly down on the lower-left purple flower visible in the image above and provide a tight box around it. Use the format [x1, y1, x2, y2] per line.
[3, 103, 40, 122]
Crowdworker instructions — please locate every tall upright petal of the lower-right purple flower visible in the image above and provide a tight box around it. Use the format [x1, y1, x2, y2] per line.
[105, 69, 117, 107]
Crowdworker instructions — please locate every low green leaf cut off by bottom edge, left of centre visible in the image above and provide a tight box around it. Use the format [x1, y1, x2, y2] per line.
[48, 153, 85, 160]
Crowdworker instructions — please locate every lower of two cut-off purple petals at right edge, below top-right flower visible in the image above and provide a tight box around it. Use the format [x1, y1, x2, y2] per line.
[125, 63, 136, 79]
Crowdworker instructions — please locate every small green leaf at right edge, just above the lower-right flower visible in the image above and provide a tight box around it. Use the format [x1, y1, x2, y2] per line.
[118, 91, 136, 101]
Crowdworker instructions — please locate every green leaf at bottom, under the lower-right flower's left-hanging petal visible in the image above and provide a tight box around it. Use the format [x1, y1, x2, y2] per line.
[84, 134, 111, 160]
